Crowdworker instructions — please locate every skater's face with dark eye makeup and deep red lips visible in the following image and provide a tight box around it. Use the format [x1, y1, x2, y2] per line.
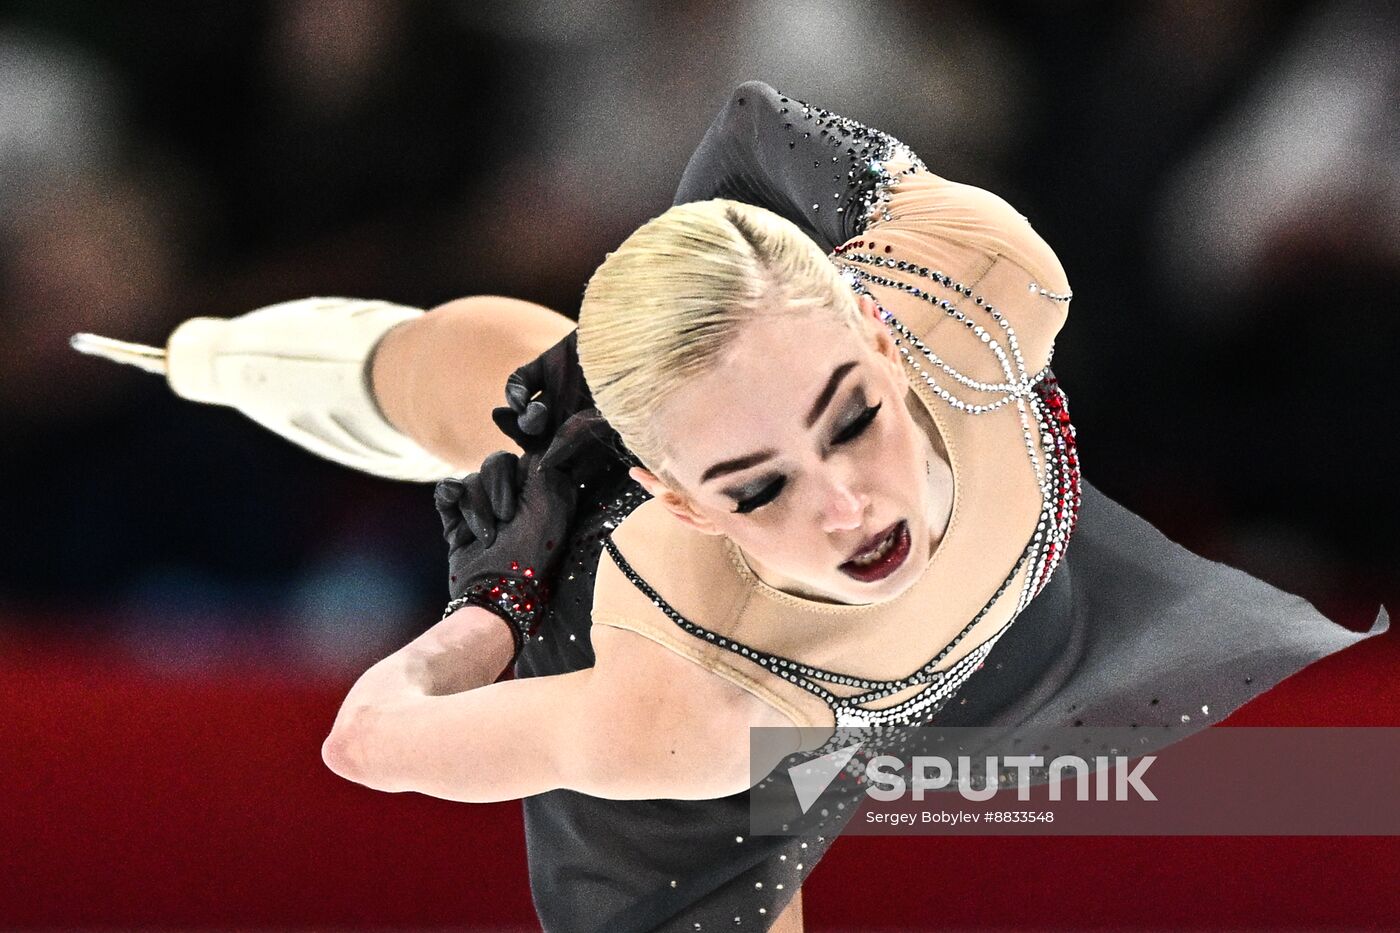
[633, 297, 951, 604]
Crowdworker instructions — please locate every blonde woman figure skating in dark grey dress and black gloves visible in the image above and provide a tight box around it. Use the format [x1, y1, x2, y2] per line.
[76, 83, 1386, 930]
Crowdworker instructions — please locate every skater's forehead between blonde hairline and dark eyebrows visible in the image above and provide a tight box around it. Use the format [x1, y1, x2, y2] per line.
[657, 314, 867, 473]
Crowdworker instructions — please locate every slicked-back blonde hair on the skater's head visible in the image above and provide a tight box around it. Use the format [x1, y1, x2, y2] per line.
[578, 199, 860, 482]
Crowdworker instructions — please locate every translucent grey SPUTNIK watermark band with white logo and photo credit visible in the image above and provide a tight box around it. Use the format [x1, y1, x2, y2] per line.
[749, 723, 1400, 838]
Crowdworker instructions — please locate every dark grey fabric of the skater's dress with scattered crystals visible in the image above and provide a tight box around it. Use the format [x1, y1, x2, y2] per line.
[515, 83, 1387, 933]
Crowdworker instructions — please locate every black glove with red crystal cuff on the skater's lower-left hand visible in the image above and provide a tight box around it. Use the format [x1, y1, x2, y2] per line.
[433, 451, 578, 660]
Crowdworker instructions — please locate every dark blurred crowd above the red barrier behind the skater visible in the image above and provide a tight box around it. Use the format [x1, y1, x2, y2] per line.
[0, 0, 1400, 664]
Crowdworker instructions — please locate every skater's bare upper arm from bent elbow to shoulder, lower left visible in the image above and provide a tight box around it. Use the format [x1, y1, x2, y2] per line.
[336, 626, 797, 803]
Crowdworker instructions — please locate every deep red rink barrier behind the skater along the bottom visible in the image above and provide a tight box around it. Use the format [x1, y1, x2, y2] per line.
[0, 610, 1400, 930]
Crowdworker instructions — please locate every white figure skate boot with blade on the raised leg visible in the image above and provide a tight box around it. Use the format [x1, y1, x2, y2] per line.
[73, 298, 461, 482]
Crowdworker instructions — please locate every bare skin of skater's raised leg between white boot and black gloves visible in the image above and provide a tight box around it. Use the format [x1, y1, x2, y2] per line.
[370, 296, 574, 472]
